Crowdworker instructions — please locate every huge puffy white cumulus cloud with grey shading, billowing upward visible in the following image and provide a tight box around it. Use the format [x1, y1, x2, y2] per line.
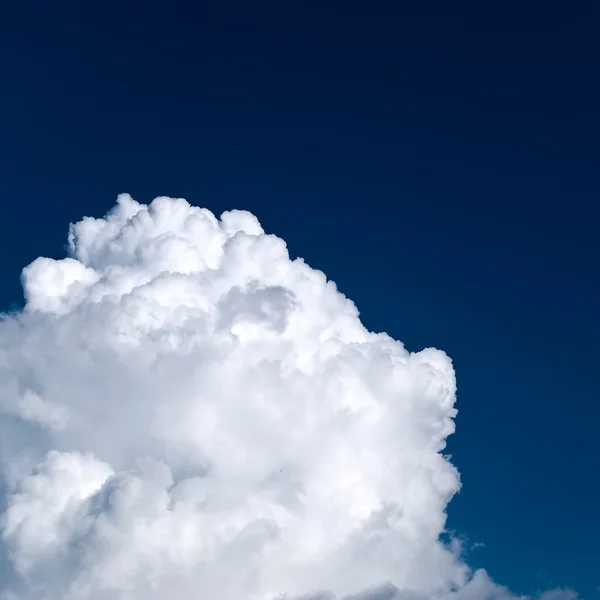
[0, 195, 568, 600]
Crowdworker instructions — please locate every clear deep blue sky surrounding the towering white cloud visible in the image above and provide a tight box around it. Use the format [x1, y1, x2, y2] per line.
[0, 0, 600, 597]
